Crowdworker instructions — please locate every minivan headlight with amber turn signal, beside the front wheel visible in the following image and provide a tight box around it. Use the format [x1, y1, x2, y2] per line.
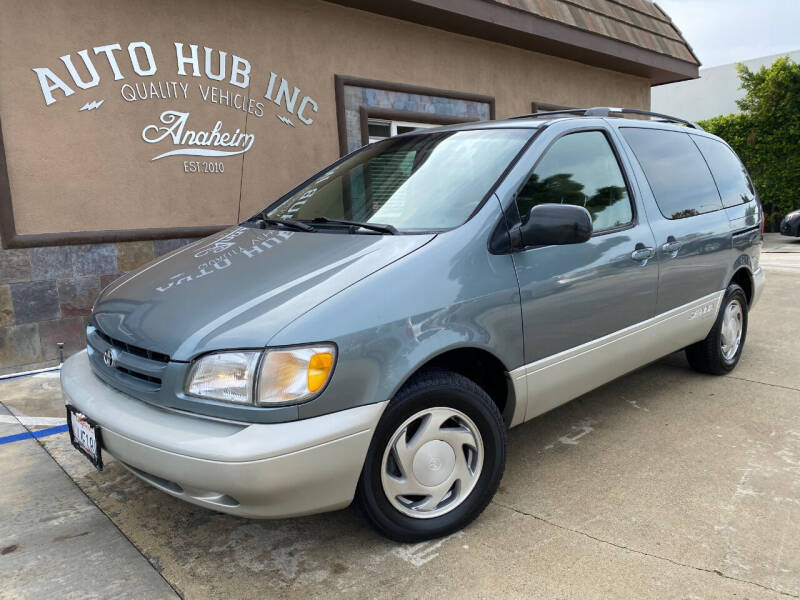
[185, 344, 336, 406]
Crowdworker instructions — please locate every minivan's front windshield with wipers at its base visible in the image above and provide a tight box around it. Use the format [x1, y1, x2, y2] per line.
[262, 129, 534, 231]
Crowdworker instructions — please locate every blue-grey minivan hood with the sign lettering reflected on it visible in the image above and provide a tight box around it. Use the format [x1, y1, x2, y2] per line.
[92, 227, 435, 361]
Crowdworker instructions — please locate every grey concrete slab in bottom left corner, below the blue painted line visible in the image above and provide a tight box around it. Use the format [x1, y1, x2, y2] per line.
[0, 396, 177, 600]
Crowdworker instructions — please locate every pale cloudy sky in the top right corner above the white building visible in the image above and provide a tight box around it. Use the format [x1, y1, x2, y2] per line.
[656, 0, 800, 67]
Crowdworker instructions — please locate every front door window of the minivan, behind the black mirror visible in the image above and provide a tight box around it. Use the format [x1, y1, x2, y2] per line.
[517, 131, 633, 231]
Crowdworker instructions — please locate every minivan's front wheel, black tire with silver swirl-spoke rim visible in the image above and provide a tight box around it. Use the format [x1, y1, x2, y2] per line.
[355, 370, 506, 542]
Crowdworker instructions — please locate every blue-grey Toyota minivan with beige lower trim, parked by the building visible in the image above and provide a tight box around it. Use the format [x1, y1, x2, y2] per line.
[61, 109, 764, 541]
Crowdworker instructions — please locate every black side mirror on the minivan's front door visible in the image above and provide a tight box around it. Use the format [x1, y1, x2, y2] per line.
[512, 204, 592, 248]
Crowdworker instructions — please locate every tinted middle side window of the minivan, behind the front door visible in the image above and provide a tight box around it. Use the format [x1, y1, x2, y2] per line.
[620, 127, 722, 219]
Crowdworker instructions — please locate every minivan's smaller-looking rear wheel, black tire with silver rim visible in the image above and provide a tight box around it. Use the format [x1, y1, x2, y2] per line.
[686, 283, 747, 375]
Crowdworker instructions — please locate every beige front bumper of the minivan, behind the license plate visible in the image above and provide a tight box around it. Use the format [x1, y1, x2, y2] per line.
[61, 350, 386, 518]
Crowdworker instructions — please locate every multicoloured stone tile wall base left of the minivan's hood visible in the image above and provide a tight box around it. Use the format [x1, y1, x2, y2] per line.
[0, 239, 194, 375]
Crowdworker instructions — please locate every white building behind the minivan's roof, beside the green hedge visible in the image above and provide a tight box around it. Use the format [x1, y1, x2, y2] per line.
[650, 50, 800, 121]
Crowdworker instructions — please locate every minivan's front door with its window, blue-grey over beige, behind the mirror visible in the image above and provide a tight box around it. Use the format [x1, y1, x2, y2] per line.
[508, 120, 658, 419]
